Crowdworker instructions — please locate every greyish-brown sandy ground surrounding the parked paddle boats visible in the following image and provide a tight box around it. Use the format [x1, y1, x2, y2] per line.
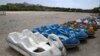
[0, 11, 100, 56]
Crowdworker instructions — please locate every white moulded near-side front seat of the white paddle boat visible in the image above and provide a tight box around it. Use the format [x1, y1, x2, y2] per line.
[20, 36, 42, 52]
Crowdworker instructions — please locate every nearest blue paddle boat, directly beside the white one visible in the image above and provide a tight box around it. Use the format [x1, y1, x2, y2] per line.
[32, 24, 79, 48]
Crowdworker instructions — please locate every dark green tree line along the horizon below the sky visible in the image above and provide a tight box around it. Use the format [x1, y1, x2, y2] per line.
[0, 3, 100, 13]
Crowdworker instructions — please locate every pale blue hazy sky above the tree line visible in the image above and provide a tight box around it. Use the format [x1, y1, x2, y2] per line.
[0, 0, 100, 9]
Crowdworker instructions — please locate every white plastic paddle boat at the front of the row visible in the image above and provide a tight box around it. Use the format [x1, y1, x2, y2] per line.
[6, 29, 66, 56]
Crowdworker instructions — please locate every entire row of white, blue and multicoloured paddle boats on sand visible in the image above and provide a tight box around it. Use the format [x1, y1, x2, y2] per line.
[6, 16, 100, 56]
